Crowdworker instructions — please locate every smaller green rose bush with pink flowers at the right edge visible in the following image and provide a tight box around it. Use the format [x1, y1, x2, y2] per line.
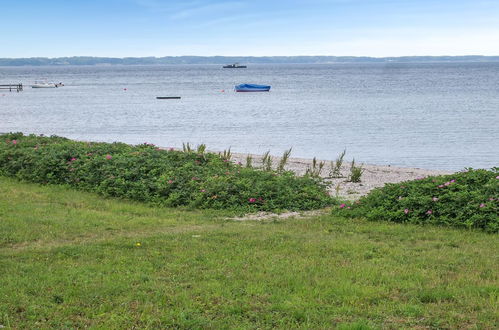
[333, 168, 499, 233]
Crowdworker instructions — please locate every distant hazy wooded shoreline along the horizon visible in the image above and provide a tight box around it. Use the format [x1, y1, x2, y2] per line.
[0, 55, 499, 66]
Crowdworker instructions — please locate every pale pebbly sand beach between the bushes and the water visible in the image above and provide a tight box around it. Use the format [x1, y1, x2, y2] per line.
[232, 153, 453, 200]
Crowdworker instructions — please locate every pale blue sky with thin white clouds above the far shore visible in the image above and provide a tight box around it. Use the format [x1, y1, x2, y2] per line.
[0, 0, 499, 58]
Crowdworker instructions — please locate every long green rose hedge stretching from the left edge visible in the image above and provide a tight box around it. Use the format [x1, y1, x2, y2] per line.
[0, 133, 333, 211]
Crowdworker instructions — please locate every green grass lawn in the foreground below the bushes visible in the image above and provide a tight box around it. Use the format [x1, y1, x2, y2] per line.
[0, 177, 499, 329]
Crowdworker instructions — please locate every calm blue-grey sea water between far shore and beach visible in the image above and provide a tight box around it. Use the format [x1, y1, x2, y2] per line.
[0, 63, 499, 170]
